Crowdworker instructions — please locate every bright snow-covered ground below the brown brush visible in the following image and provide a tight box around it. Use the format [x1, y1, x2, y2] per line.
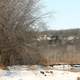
[0, 65, 80, 80]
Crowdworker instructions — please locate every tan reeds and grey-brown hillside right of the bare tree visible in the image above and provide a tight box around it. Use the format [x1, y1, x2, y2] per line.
[39, 29, 80, 65]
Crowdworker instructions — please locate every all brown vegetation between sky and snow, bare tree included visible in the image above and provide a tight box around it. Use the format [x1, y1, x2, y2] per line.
[0, 0, 80, 65]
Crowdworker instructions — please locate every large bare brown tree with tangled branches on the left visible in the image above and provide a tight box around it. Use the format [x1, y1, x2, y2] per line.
[0, 0, 46, 65]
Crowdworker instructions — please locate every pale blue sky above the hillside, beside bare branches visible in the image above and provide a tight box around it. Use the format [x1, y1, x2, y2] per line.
[44, 0, 80, 29]
